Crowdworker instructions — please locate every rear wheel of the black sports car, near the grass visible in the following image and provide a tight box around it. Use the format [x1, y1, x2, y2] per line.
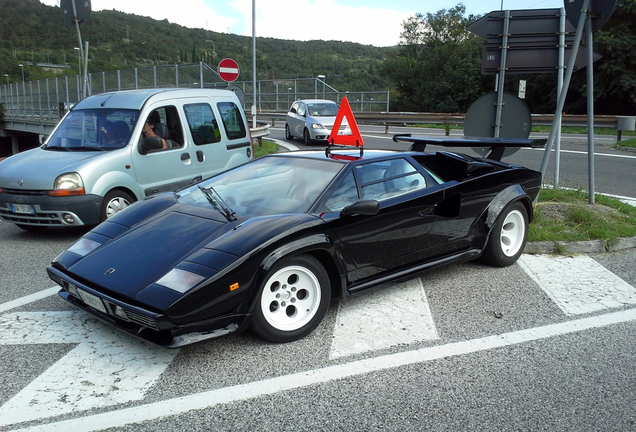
[481, 201, 528, 267]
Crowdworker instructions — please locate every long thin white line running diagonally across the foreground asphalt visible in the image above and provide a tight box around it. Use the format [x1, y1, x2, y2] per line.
[11, 309, 636, 432]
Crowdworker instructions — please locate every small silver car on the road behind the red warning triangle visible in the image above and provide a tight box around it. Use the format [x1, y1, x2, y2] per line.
[285, 99, 351, 145]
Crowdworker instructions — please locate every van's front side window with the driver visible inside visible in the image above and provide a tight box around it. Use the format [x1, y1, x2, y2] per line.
[140, 105, 185, 152]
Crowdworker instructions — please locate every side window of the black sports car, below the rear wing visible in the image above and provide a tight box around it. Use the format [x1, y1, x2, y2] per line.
[356, 159, 426, 201]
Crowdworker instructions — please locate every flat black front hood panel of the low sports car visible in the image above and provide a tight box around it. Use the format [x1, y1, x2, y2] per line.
[68, 205, 231, 299]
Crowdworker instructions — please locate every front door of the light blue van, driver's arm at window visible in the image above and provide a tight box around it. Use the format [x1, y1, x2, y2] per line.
[132, 104, 196, 196]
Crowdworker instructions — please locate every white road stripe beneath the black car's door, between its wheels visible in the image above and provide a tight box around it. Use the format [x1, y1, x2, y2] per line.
[329, 278, 439, 359]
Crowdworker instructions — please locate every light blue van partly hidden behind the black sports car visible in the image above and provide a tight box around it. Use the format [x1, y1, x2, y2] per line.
[0, 89, 252, 230]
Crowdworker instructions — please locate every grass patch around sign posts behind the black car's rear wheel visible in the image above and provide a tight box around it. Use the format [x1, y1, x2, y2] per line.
[528, 189, 636, 245]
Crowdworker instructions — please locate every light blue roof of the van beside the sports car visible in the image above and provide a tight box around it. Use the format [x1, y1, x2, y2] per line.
[73, 88, 235, 110]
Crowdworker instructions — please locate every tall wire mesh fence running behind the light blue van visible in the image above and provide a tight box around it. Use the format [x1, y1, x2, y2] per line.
[0, 63, 389, 122]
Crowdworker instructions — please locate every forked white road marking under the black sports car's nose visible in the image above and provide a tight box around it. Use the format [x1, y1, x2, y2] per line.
[0, 311, 178, 430]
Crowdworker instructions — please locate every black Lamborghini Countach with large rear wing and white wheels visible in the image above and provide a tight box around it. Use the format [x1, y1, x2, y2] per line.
[47, 136, 545, 347]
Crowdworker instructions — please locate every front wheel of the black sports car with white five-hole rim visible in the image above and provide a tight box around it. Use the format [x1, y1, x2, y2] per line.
[251, 255, 331, 343]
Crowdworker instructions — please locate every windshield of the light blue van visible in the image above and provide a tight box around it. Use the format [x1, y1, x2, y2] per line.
[43, 109, 139, 151]
